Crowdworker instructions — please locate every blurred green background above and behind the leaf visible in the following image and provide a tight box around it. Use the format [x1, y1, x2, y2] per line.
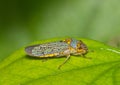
[0, 0, 120, 61]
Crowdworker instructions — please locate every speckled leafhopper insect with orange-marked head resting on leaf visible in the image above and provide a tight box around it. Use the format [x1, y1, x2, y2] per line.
[25, 38, 88, 69]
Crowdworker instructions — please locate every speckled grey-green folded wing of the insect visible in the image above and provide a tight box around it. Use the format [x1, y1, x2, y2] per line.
[25, 41, 69, 57]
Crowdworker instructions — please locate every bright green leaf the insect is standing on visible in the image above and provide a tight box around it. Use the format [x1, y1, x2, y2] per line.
[0, 39, 120, 85]
